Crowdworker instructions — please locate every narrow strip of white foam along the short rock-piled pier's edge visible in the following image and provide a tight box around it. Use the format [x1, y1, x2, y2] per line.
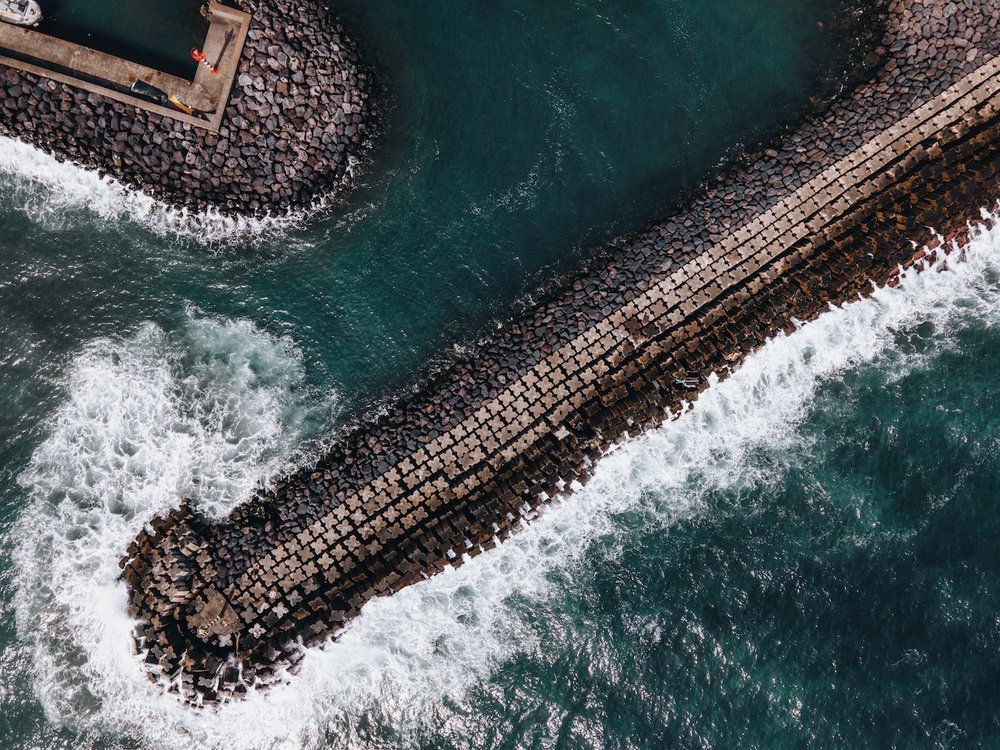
[0, 136, 322, 244]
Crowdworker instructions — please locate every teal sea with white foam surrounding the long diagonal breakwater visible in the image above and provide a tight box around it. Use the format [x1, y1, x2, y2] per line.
[0, 0, 1000, 750]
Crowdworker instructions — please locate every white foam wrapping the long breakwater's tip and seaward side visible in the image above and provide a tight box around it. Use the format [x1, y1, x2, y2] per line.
[11, 207, 1000, 748]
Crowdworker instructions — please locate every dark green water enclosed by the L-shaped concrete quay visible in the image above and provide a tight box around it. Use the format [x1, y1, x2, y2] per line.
[39, 0, 208, 79]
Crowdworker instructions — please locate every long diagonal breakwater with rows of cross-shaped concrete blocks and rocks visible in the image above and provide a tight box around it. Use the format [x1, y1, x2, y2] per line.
[122, 0, 1000, 703]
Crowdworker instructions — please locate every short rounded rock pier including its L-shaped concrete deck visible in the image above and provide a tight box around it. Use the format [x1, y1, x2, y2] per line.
[0, 0, 373, 215]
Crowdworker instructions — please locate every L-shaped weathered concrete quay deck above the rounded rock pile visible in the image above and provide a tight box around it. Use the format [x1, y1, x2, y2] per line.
[0, 3, 250, 132]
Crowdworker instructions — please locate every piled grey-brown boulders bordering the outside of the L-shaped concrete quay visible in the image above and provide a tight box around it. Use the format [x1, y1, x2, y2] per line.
[0, 0, 373, 215]
